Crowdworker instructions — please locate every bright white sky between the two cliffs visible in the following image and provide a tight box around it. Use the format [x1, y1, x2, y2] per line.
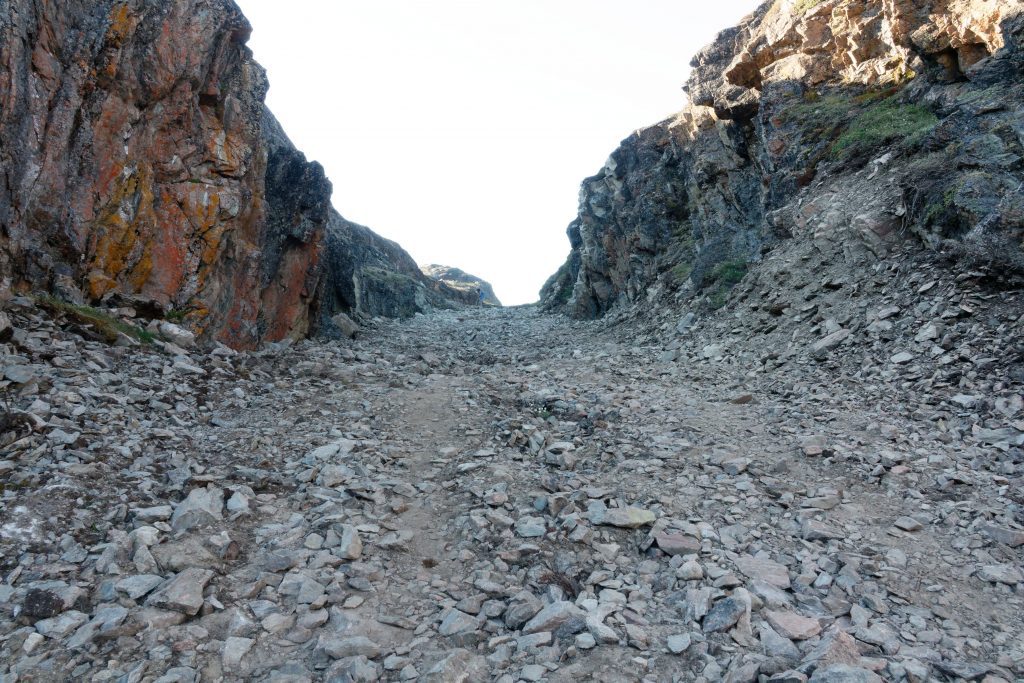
[237, 0, 758, 304]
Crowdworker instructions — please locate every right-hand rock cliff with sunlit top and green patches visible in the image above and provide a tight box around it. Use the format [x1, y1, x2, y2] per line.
[542, 0, 1024, 317]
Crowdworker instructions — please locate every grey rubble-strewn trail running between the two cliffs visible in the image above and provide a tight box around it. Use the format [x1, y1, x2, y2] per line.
[0, 299, 1024, 683]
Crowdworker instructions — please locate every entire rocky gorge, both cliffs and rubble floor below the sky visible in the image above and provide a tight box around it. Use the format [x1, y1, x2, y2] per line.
[0, 0, 1024, 683]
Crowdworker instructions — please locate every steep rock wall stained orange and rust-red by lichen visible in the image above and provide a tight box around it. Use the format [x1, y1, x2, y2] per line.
[0, 0, 460, 347]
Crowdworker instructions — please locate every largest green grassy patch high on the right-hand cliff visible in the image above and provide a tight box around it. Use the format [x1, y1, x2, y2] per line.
[831, 97, 939, 160]
